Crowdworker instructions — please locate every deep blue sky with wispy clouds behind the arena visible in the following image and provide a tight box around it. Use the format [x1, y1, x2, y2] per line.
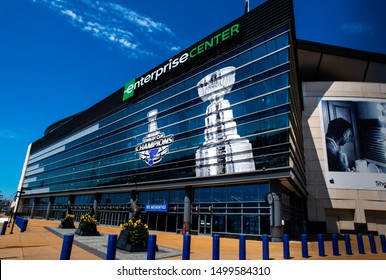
[0, 0, 386, 198]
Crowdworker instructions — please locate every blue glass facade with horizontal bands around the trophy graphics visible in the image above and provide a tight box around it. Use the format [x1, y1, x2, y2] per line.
[25, 28, 290, 195]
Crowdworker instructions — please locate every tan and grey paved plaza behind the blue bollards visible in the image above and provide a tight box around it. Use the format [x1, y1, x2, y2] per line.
[0, 219, 386, 260]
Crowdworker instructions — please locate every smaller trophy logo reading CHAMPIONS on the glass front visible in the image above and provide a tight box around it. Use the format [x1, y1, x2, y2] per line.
[135, 110, 173, 166]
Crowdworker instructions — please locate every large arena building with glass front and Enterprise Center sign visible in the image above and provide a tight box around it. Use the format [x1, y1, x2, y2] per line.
[18, 0, 386, 236]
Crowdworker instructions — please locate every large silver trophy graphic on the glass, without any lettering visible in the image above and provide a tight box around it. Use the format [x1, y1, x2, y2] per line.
[196, 67, 255, 177]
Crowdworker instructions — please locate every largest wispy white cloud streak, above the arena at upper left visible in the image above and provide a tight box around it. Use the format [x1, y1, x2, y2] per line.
[33, 0, 185, 57]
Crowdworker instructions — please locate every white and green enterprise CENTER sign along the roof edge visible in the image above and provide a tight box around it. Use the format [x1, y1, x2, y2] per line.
[123, 24, 239, 101]
